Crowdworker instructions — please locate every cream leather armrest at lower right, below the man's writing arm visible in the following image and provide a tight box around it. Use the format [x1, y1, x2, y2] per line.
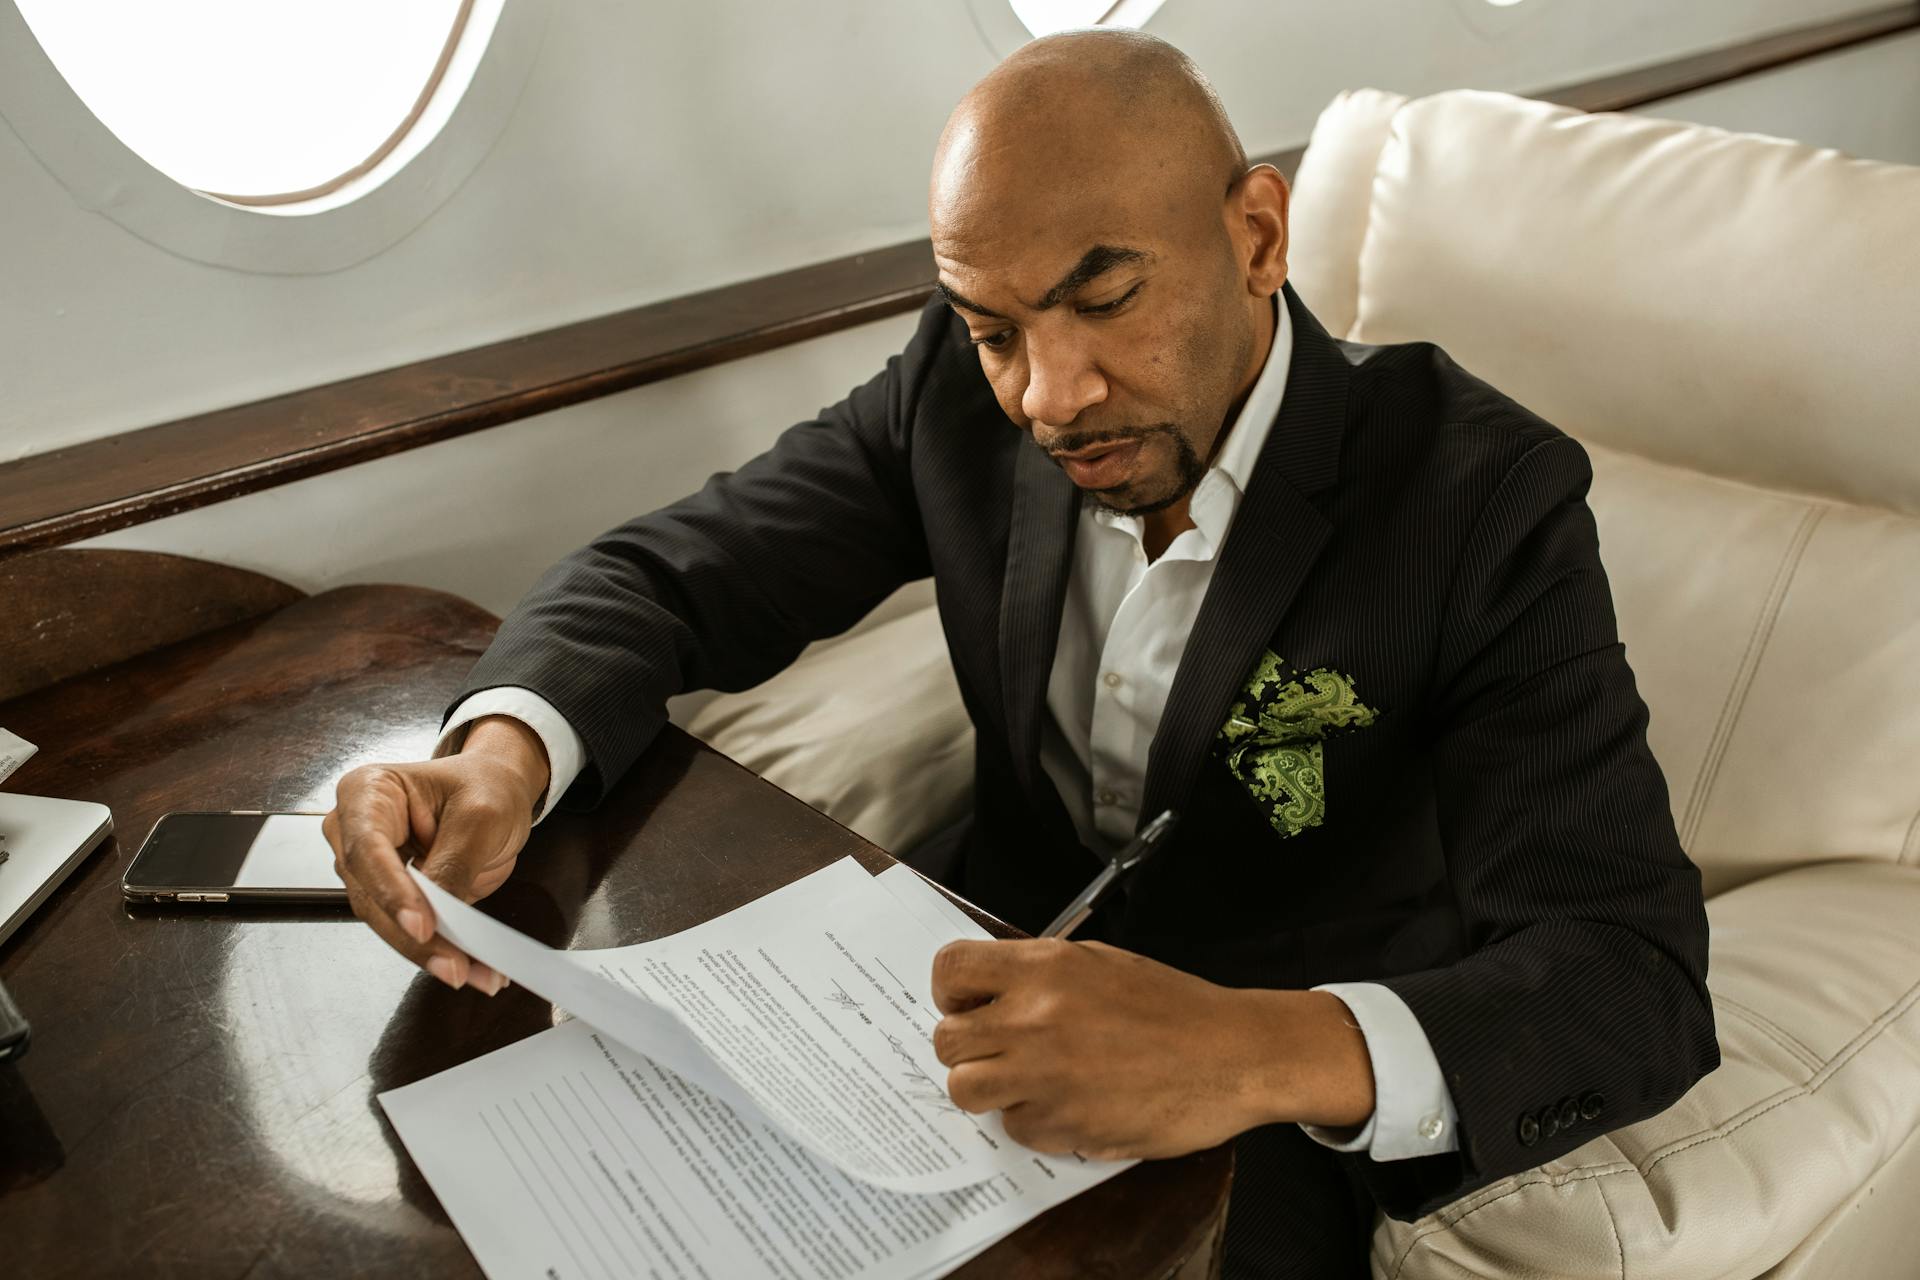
[1373, 862, 1920, 1280]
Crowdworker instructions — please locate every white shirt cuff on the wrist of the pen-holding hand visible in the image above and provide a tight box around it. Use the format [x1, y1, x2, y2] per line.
[1300, 983, 1459, 1161]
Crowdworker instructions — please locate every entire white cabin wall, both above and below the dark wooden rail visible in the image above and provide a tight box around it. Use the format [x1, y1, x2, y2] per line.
[11, 0, 1920, 612]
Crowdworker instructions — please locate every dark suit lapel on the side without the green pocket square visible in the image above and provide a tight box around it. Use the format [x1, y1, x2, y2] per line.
[1000, 445, 1079, 798]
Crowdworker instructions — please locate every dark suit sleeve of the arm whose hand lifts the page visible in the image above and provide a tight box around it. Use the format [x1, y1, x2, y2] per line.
[449, 305, 950, 808]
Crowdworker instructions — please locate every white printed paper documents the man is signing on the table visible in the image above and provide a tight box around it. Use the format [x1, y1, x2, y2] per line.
[380, 858, 1127, 1280]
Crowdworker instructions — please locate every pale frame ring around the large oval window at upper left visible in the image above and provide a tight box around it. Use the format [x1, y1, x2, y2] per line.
[0, 0, 549, 274]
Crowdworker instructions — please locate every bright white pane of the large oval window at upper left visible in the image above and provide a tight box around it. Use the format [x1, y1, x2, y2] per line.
[17, 0, 488, 213]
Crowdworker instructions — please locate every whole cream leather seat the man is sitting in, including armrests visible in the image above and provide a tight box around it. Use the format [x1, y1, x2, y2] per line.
[691, 90, 1920, 1280]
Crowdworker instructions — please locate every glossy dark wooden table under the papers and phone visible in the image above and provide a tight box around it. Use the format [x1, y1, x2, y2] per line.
[0, 587, 1231, 1278]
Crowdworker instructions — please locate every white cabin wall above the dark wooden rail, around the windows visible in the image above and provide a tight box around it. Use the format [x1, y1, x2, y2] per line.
[0, 0, 1874, 459]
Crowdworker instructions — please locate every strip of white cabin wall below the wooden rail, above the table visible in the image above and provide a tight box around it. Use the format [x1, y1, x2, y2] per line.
[83, 317, 925, 614]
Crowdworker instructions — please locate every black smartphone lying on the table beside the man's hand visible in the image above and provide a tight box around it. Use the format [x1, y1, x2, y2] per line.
[121, 810, 348, 906]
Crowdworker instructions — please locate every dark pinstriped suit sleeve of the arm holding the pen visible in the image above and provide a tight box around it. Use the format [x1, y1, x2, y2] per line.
[1356, 436, 1718, 1219]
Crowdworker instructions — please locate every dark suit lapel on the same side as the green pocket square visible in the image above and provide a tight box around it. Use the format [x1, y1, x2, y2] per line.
[1136, 286, 1352, 825]
